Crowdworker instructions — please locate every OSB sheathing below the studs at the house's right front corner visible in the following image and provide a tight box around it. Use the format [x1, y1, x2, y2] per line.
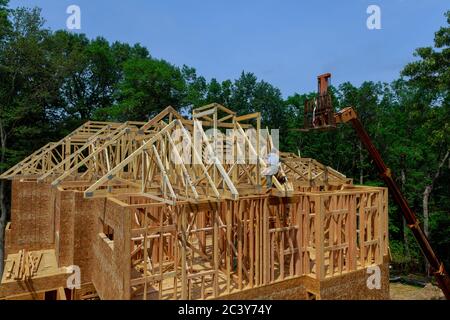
[320, 259, 389, 300]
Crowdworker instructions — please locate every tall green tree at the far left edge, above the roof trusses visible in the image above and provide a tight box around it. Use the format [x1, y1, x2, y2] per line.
[0, 6, 59, 270]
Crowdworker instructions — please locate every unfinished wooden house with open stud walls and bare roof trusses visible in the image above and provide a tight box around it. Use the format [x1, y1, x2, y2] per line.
[0, 104, 389, 300]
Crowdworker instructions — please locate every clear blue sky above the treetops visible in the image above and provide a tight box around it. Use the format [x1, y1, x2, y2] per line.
[10, 0, 450, 97]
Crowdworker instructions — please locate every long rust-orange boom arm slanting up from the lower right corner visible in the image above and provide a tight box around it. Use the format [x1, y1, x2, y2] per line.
[335, 107, 450, 299]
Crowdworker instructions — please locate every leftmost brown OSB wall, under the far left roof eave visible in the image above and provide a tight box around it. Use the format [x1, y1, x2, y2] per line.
[6, 180, 54, 254]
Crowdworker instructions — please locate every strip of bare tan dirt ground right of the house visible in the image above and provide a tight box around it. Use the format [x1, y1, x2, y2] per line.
[389, 282, 445, 300]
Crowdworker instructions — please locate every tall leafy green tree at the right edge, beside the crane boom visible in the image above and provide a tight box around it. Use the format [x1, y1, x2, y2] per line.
[402, 11, 450, 270]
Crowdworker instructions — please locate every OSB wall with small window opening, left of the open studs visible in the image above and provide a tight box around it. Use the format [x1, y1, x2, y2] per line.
[92, 200, 131, 300]
